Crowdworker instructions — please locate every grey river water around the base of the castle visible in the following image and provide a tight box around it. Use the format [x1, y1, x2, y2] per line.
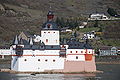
[0, 64, 120, 80]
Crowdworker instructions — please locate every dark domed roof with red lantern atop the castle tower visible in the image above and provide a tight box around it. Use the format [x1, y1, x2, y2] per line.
[42, 11, 59, 30]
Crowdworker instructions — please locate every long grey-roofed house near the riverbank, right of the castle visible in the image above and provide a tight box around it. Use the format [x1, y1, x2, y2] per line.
[99, 46, 120, 56]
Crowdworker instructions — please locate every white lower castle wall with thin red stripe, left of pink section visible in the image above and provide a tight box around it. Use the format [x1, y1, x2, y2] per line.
[11, 50, 64, 72]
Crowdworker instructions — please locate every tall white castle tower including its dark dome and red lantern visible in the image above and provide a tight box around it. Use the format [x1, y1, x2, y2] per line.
[41, 11, 59, 45]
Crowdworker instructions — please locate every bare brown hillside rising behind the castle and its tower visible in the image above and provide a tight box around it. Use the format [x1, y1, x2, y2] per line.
[0, 0, 120, 45]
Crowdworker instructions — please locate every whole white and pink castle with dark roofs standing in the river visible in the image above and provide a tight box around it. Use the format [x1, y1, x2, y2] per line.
[10, 11, 96, 72]
